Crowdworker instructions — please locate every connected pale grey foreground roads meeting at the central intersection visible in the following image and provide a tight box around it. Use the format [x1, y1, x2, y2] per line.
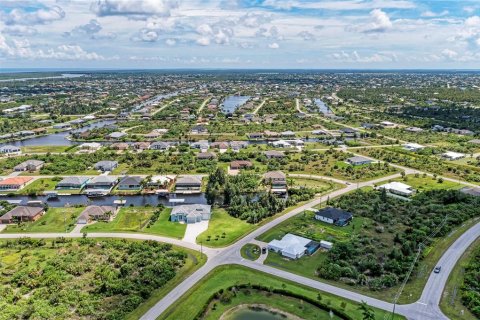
[0, 172, 480, 320]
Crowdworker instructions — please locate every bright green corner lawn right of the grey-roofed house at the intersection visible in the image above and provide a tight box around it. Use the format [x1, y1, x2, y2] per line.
[197, 209, 256, 247]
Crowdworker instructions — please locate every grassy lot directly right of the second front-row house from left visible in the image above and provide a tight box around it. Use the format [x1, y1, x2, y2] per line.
[82, 207, 156, 232]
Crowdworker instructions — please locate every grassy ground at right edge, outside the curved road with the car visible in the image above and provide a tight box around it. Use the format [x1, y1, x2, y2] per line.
[440, 235, 480, 320]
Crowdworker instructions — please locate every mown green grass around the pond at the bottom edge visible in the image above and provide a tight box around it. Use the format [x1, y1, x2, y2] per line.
[159, 265, 403, 320]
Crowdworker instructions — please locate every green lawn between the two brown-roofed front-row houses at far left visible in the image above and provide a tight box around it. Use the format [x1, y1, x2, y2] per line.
[3, 208, 83, 233]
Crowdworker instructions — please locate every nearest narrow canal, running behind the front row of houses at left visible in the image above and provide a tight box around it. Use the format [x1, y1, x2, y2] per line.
[0, 193, 207, 207]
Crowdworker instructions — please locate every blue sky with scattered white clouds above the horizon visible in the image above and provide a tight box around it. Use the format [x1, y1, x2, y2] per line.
[0, 0, 480, 68]
